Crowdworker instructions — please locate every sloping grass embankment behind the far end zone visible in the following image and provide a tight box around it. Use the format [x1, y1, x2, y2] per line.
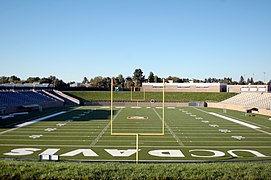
[65, 91, 236, 102]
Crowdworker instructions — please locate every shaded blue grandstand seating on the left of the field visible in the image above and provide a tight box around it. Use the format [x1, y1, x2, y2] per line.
[0, 84, 80, 114]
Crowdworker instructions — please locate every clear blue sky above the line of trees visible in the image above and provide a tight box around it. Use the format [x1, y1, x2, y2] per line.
[0, 0, 271, 82]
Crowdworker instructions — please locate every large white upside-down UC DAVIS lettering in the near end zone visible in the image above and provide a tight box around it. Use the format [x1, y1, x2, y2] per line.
[4, 148, 269, 159]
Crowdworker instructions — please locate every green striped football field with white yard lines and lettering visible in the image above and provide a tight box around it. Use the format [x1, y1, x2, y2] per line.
[0, 106, 271, 162]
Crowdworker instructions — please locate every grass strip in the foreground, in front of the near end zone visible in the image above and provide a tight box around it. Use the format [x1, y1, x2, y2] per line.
[0, 161, 271, 179]
